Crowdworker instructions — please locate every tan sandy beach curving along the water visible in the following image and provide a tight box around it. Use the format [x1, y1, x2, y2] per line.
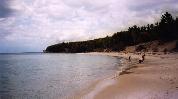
[73, 52, 178, 99]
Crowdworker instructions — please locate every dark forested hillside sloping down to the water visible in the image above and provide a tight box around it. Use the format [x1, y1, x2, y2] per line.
[45, 12, 178, 53]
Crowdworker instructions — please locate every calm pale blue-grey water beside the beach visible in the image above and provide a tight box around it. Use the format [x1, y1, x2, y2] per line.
[0, 54, 124, 99]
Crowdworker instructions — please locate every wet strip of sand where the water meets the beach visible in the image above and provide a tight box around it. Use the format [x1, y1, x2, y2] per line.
[71, 53, 138, 99]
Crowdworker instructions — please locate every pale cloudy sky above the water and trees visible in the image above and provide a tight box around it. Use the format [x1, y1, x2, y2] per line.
[0, 0, 178, 53]
